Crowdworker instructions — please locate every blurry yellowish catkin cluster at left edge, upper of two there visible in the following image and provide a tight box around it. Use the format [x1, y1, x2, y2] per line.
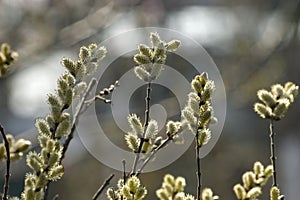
[0, 43, 19, 77]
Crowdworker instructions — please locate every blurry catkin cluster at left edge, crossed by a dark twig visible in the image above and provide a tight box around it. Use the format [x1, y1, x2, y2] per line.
[0, 134, 31, 161]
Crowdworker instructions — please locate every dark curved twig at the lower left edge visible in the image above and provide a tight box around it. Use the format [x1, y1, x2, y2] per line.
[0, 125, 10, 200]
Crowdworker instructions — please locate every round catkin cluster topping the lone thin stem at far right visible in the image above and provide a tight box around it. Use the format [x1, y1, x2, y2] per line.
[254, 82, 299, 120]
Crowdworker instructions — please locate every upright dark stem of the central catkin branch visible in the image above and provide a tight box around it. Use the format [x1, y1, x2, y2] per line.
[131, 82, 151, 175]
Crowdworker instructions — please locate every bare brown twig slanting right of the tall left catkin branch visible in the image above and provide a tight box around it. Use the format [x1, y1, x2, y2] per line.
[60, 78, 97, 162]
